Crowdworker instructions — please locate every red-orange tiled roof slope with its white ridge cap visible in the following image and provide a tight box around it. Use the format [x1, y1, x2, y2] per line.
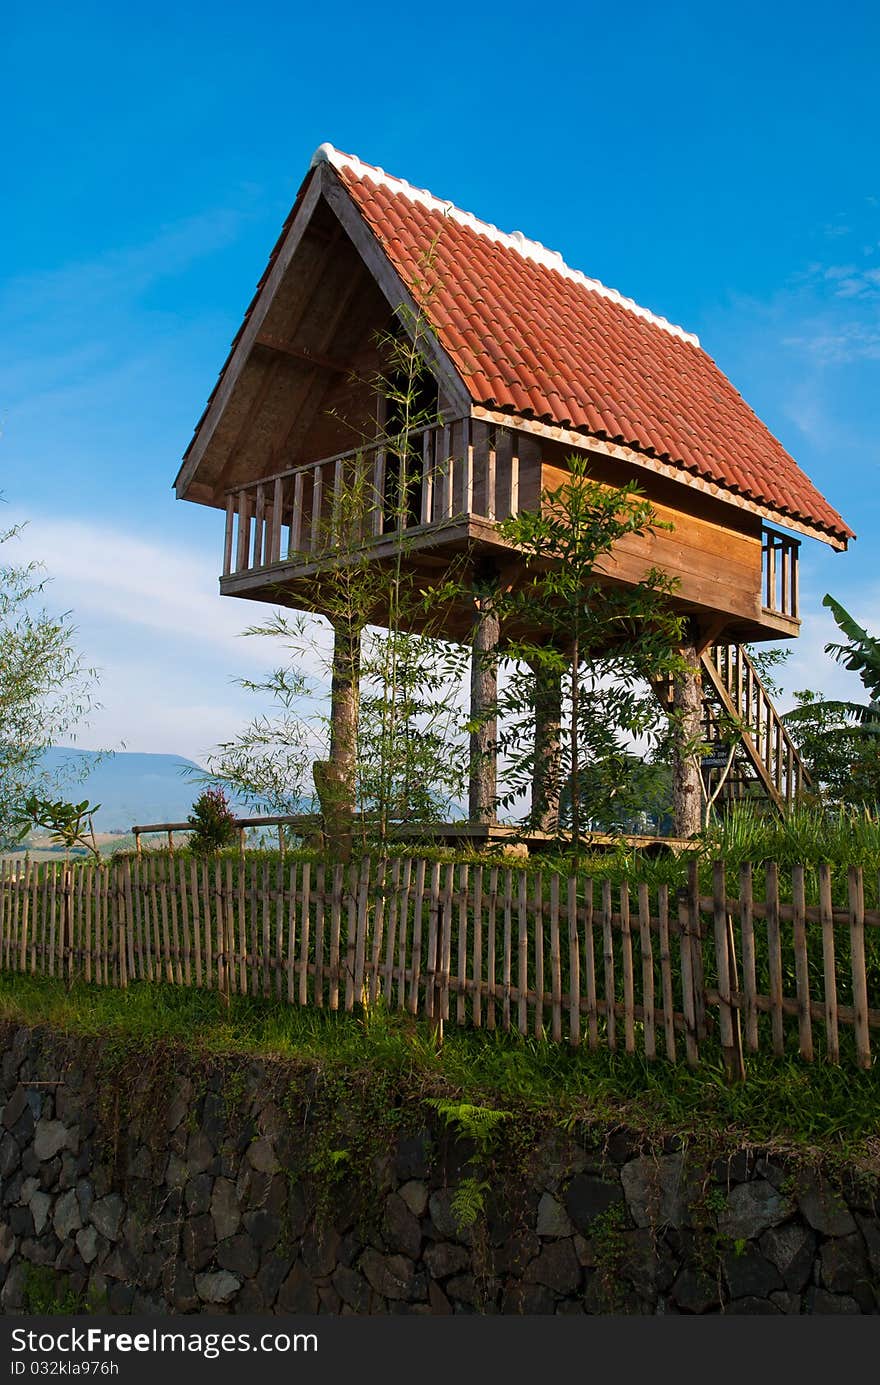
[316, 145, 852, 542]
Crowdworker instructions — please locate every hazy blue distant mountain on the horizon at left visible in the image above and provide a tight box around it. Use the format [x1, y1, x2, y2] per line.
[33, 745, 244, 832]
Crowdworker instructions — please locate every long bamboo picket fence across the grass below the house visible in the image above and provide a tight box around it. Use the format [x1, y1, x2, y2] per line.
[0, 855, 880, 1072]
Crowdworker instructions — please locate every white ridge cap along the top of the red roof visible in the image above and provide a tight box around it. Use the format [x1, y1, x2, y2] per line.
[309, 144, 700, 346]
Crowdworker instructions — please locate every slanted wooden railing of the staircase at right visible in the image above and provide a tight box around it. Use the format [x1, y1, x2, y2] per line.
[703, 644, 809, 807]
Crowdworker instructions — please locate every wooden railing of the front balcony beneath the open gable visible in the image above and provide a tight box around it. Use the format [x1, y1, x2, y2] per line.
[223, 418, 520, 576]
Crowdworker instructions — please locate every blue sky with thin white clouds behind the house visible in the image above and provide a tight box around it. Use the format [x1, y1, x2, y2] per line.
[0, 0, 880, 759]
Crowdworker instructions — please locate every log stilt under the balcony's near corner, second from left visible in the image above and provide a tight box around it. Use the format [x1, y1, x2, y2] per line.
[468, 580, 500, 824]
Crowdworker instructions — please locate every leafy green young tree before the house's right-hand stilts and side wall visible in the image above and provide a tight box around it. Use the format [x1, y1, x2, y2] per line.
[496, 454, 682, 856]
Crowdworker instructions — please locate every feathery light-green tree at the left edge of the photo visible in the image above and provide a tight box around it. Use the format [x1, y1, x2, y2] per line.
[0, 509, 96, 843]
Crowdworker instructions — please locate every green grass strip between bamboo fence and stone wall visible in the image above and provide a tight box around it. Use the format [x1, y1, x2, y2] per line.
[0, 975, 880, 1172]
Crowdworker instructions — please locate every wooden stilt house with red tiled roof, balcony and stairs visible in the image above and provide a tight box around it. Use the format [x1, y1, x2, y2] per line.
[176, 145, 852, 821]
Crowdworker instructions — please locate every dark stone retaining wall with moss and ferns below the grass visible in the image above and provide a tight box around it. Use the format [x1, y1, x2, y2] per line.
[0, 1026, 880, 1314]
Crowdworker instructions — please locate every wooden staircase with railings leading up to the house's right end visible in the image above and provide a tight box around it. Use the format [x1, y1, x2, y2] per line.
[657, 644, 809, 813]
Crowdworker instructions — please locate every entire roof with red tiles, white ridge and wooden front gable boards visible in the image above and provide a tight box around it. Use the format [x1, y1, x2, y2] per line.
[177, 145, 852, 547]
